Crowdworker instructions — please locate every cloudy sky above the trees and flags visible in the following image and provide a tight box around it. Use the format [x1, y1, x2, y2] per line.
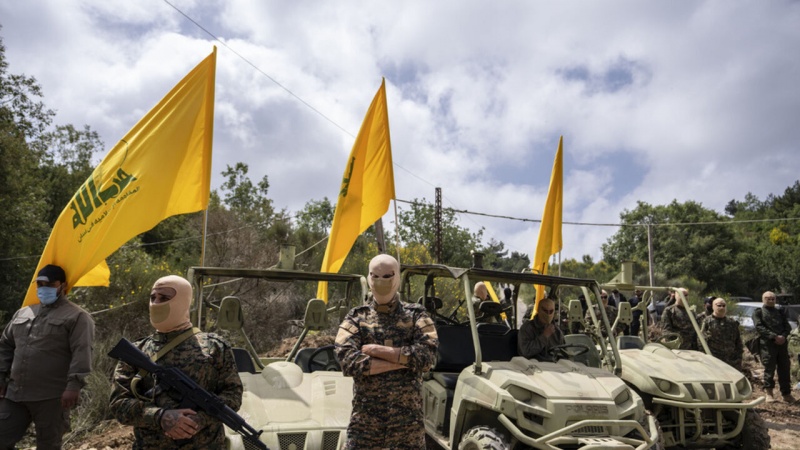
[0, 0, 800, 259]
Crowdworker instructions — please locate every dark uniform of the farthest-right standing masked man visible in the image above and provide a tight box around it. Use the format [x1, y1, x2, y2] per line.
[753, 306, 792, 395]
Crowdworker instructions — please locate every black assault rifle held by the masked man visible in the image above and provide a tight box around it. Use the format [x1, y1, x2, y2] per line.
[108, 338, 269, 450]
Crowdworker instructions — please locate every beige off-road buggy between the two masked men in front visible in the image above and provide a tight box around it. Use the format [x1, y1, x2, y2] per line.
[188, 265, 367, 450]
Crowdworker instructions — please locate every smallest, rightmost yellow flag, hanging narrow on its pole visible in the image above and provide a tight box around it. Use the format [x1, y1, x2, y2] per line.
[533, 136, 564, 315]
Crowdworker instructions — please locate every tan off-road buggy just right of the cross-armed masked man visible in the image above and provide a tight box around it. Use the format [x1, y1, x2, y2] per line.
[401, 265, 662, 450]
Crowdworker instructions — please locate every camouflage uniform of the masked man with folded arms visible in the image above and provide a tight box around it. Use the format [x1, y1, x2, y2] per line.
[335, 295, 439, 449]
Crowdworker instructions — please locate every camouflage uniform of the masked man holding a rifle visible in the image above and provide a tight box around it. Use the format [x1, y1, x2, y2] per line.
[110, 330, 242, 450]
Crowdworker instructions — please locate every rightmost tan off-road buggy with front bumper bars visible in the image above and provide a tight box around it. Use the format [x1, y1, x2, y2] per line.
[602, 263, 770, 450]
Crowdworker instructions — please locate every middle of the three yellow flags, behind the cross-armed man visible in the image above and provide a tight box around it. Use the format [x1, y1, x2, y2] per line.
[317, 80, 394, 302]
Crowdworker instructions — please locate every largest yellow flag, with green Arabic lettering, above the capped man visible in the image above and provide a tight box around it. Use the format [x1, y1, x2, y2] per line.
[23, 47, 217, 306]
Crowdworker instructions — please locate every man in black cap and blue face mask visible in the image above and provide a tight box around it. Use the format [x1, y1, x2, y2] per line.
[0, 264, 94, 450]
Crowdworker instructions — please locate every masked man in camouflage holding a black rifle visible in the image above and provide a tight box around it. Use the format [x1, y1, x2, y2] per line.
[110, 275, 242, 450]
